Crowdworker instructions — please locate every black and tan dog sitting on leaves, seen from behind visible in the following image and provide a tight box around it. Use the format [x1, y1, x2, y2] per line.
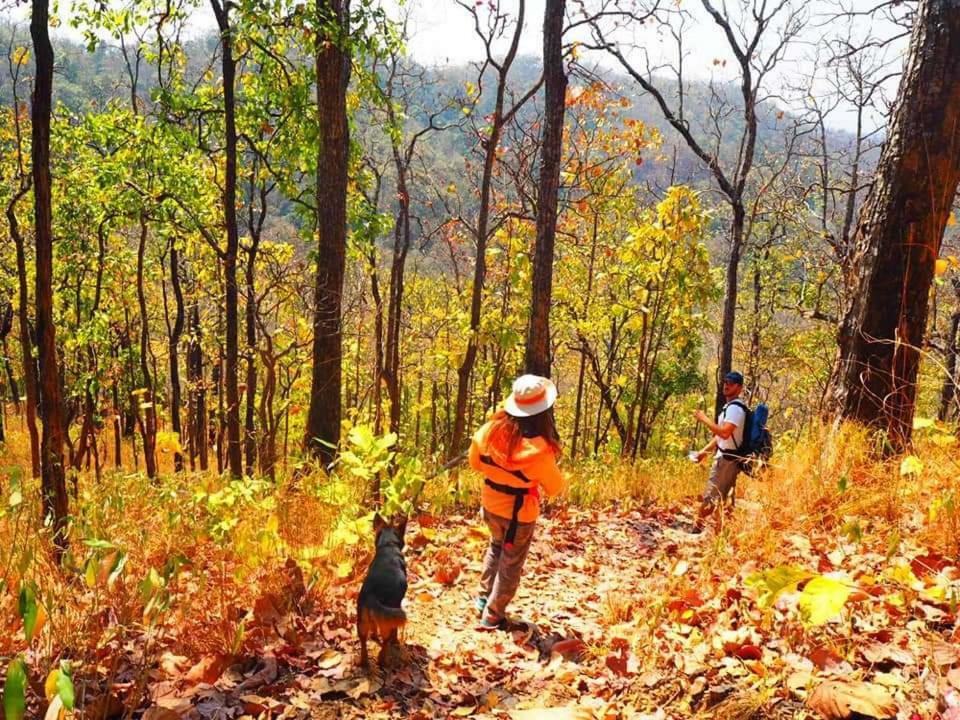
[357, 514, 407, 672]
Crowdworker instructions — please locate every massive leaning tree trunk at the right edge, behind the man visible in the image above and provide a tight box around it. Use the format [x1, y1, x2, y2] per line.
[830, 0, 960, 450]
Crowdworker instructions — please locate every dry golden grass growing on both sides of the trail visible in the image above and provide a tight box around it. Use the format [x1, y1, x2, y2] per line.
[0, 414, 960, 712]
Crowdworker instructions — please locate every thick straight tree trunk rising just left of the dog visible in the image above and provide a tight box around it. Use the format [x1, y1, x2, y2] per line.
[304, 0, 350, 463]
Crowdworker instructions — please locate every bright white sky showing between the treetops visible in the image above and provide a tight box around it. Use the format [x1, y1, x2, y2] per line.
[0, 0, 906, 130]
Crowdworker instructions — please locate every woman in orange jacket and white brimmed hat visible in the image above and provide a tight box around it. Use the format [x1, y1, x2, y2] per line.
[470, 375, 566, 630]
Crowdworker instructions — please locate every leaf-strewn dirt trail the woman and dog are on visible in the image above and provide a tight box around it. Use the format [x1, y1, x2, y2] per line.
[201, 508, 736, 718]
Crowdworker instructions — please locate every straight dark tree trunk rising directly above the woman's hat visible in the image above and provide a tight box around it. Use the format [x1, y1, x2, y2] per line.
[524, 0, 567, 376]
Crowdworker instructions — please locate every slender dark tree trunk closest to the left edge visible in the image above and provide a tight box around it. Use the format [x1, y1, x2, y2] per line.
[30, 0, 68, 551]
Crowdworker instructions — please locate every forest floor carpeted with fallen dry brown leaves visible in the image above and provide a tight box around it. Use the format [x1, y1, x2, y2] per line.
[143, 483, 960, 720]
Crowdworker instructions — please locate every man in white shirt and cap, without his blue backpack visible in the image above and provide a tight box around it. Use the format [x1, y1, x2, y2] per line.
[693, 370, 749, 515]
